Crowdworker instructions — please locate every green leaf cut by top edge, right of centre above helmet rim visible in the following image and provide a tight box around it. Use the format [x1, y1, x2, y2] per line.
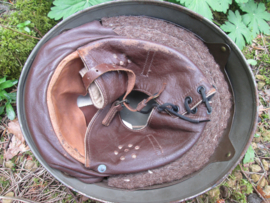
[177, 0, 232, 20]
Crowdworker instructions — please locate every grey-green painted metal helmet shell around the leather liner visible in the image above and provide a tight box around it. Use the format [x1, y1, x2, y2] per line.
[17, 0, 258, 203]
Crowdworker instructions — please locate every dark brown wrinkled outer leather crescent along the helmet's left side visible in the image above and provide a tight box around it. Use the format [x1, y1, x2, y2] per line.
[24, 21, 118, 183]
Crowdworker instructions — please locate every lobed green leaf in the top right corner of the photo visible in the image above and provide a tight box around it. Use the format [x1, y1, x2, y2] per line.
[240, 1, 270, 38]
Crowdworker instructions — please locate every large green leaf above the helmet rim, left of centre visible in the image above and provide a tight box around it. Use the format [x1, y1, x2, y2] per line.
[48, 0, 110, 20]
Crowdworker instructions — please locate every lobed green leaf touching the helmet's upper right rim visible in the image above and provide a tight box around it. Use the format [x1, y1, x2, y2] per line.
[220, 10, 252, 50]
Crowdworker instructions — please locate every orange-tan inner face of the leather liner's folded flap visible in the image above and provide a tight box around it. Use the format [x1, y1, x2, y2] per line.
[47, 52, 87, 163]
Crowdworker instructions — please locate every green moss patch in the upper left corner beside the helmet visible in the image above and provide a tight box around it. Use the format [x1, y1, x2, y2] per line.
[0, 0, 56, 79]
